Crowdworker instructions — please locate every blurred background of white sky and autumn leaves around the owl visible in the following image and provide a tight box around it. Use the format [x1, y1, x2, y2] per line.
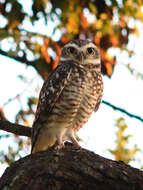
[0, 0, 143, 175]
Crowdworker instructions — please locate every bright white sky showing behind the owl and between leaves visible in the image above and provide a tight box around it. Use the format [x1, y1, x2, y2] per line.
[0, 1, 143, 175]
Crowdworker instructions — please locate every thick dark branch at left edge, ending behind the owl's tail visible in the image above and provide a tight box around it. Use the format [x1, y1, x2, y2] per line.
[0, 120, 32, 137]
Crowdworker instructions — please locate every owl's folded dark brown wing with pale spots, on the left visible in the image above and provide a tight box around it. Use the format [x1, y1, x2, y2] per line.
[31, 63, 74, 149]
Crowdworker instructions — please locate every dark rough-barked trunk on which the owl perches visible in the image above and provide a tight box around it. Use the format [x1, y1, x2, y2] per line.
[0, 146, 143, 190]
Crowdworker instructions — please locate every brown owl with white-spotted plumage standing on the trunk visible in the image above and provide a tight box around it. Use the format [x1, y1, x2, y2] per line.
[31, 39, 103, 153]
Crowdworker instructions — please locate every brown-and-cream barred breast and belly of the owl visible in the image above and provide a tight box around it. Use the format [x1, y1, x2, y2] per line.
[51, 69, 100, 126]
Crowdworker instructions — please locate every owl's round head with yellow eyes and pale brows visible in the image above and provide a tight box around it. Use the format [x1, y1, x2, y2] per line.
[60, 40, 101, 68]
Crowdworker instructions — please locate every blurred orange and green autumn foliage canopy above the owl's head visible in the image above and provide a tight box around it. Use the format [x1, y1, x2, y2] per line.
[0, 0, 143, 78]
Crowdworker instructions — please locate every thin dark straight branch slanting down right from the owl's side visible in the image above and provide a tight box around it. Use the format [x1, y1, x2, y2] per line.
[102, 100, 143, 122]
